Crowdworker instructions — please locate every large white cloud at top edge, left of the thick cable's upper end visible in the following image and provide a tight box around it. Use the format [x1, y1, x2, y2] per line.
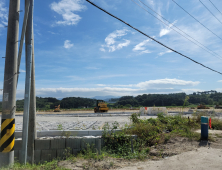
[50, 0, 86, 25]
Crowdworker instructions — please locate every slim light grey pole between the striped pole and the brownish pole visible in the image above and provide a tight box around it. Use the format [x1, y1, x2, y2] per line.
[20, 0, 34, 164]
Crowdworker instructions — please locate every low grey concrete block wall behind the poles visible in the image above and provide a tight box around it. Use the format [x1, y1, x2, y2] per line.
[14, 138, 104, 163]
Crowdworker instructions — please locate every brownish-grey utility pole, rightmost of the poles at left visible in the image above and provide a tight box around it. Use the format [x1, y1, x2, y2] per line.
[27, 12, 37, 164]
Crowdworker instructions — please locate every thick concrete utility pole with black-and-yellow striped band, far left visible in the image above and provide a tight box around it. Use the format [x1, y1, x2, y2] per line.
[0, 0, 20, 167]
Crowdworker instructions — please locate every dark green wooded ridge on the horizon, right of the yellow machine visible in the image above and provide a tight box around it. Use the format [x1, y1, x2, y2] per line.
[114, 93, 222, 107]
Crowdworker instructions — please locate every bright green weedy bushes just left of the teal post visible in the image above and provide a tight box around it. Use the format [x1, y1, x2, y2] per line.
[125, 113, 200, 146]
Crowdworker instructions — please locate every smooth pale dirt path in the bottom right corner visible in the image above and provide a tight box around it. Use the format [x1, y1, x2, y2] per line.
[119, 147, 222, 170]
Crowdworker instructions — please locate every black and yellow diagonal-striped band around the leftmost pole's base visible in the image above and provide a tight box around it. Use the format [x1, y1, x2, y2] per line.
[0, 119, 15, 152]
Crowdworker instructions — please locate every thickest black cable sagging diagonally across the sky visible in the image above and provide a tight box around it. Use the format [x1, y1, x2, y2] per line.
[86, 0, 222, 75]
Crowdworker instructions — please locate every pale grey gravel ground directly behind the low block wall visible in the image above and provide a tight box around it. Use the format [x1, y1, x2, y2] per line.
[0, 115, 146, 131]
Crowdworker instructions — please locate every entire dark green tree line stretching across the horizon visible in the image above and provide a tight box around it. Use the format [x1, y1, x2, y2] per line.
[0, 93, 222, 111]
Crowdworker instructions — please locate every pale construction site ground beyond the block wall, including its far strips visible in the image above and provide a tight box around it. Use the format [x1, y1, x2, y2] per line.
[0, 108, 222, 131]
